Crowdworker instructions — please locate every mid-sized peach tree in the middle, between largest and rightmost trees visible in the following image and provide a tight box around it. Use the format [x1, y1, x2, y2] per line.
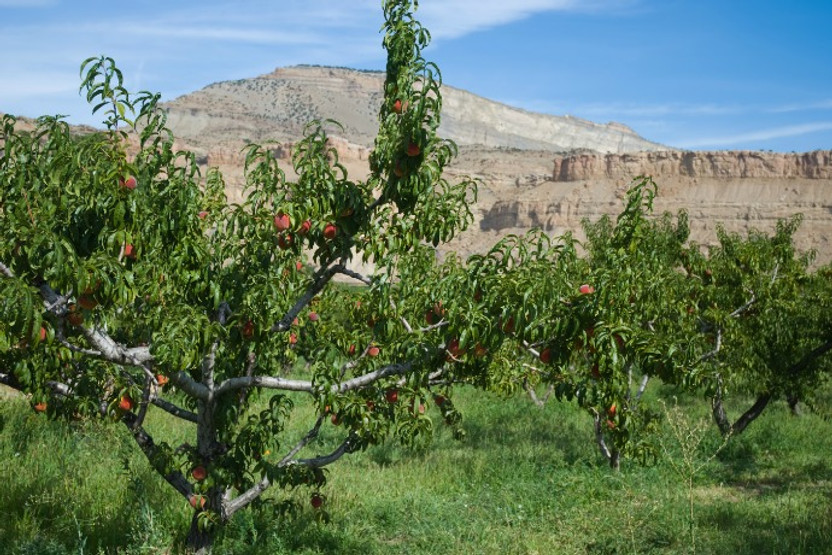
[468, 177, 701, 469]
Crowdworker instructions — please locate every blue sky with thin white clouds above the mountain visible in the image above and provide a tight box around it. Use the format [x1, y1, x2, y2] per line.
[0, 0, 832, 152]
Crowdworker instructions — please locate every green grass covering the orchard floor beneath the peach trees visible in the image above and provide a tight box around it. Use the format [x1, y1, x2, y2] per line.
[0, 391, 832, 555]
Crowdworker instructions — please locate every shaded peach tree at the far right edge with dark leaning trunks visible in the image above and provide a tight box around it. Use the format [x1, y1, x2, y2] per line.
[683, 216, 832, 435]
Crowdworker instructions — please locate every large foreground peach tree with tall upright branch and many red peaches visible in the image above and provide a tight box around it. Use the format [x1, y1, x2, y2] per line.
[0, 0, 488, 552]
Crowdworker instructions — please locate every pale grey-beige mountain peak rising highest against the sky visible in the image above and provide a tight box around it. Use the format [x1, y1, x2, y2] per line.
[165, 66, 666, 153]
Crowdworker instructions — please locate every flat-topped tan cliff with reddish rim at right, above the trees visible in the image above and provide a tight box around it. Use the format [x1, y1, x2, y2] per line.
[480, 151, 832, 263]
